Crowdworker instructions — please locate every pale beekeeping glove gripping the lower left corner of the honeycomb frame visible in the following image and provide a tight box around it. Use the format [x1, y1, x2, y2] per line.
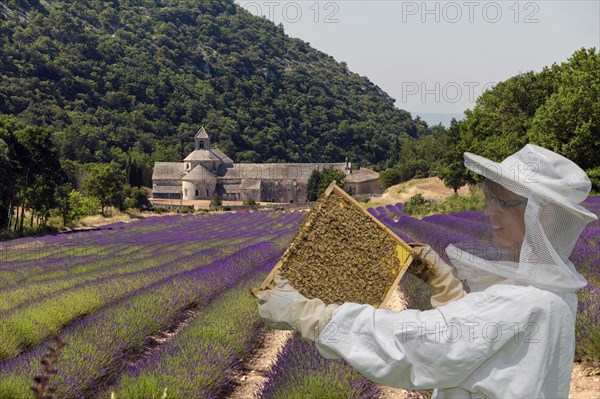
[255, 275, 339, 341]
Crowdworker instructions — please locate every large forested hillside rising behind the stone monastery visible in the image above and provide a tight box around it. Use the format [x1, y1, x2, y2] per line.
[0, 0, 425, 177]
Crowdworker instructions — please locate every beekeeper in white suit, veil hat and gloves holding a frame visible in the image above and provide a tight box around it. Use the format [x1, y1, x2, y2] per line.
[259, 144, 597, 399]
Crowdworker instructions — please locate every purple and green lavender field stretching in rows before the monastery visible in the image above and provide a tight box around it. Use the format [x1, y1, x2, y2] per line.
[0, 197, 600, 398]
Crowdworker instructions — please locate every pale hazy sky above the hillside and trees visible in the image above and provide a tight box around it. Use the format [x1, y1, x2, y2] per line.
[236, 0, 600, 113]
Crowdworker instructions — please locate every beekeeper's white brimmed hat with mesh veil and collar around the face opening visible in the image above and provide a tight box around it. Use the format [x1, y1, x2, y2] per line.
[447, 144, 597, 292]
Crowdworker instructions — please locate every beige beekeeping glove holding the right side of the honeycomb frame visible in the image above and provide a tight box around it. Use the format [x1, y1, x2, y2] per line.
[408, 244, 467, 308]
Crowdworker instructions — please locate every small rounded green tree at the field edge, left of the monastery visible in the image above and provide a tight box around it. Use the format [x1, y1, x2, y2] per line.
[83, 162, 125, 215]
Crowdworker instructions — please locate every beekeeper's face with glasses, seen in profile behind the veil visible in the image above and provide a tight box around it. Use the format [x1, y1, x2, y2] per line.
[483, 180, 527, 261]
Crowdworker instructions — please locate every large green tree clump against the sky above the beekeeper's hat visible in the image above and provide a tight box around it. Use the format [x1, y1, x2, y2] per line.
[460, 48, 600, 169]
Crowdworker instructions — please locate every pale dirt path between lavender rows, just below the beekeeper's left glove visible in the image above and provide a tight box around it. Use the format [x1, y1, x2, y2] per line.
[228, 328, 293, 399]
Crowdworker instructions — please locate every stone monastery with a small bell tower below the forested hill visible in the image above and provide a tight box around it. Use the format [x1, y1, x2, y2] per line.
[152, 127, 382, 203]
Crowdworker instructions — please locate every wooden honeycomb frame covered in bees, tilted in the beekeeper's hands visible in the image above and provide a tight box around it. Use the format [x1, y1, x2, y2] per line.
[256, 181, 412, 307]
